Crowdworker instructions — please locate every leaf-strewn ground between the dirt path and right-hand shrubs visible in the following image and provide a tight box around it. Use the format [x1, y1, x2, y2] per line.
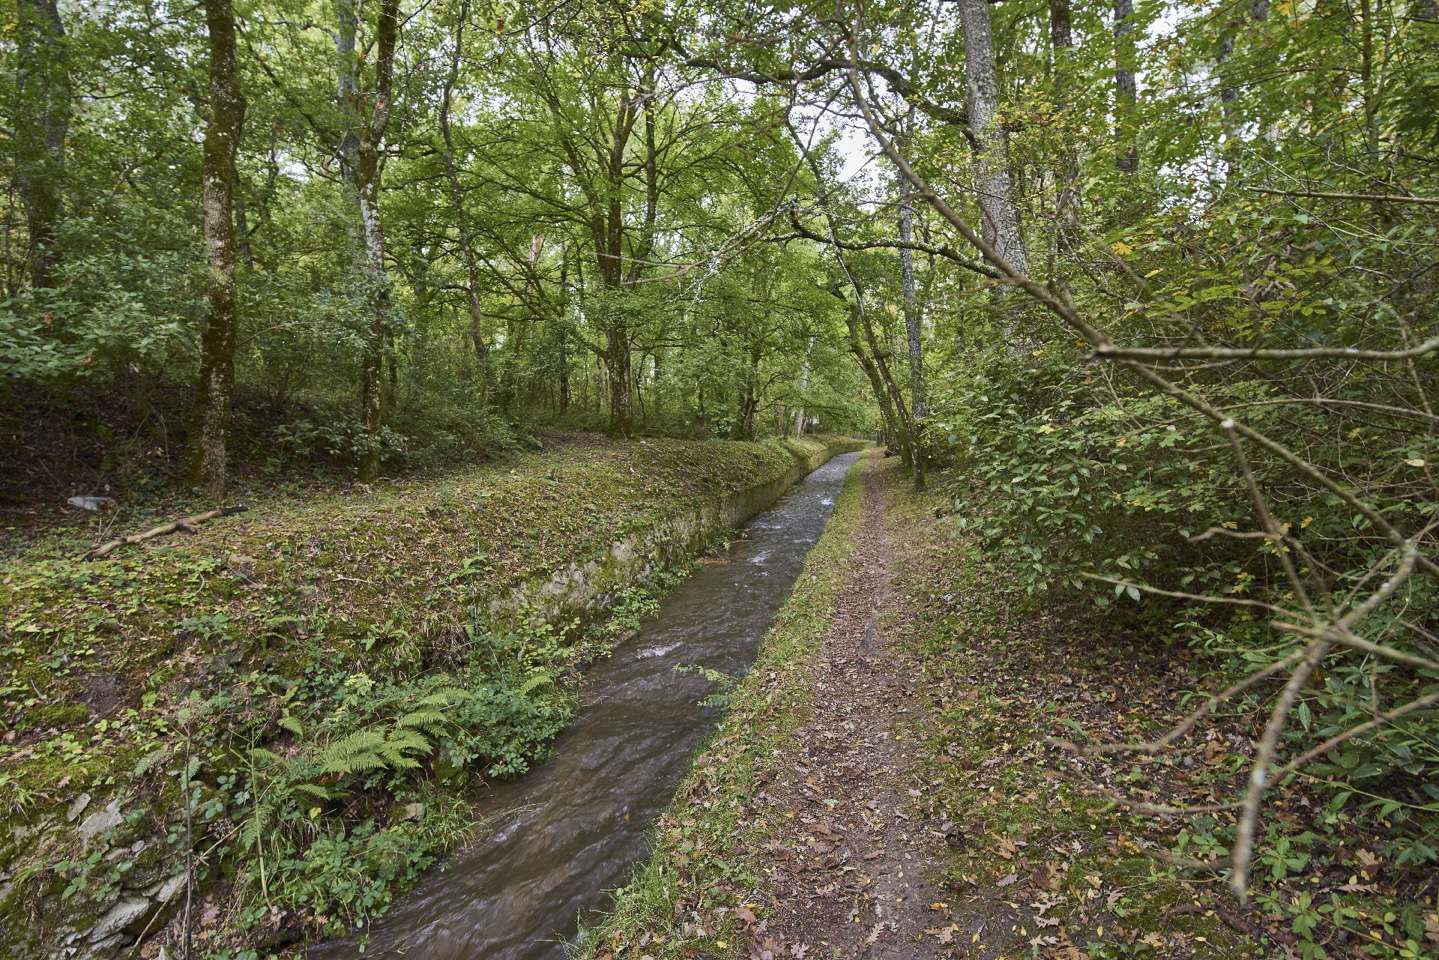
[889, 474, 1439, 960]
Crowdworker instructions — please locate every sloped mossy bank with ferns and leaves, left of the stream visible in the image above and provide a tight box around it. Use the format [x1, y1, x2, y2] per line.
[0, 438, 856, 957]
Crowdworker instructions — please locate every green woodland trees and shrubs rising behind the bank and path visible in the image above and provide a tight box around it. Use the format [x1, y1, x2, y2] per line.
[0, 0, 1439, 956]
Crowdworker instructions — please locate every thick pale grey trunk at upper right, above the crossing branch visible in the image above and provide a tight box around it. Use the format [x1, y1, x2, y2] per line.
[958, 0, 1029, 273]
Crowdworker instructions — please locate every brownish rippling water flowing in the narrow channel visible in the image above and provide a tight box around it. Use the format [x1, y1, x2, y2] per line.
[309, 453, 859, 960]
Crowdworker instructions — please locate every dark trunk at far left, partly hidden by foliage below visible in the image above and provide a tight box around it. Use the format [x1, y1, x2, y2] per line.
[14, 0, 71, 289]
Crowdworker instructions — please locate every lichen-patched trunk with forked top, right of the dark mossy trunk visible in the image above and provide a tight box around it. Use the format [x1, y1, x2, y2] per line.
[335, 0, 400, 484]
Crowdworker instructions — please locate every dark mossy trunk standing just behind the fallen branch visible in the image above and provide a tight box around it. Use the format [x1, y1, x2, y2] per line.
[186, 0, 245, 499]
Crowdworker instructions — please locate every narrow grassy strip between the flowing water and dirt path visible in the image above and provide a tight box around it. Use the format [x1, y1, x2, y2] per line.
[578, 458, 868, 957]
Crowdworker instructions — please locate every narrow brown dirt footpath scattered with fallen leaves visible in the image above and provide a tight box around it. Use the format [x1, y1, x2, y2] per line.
[761, 455, 957, 959]
